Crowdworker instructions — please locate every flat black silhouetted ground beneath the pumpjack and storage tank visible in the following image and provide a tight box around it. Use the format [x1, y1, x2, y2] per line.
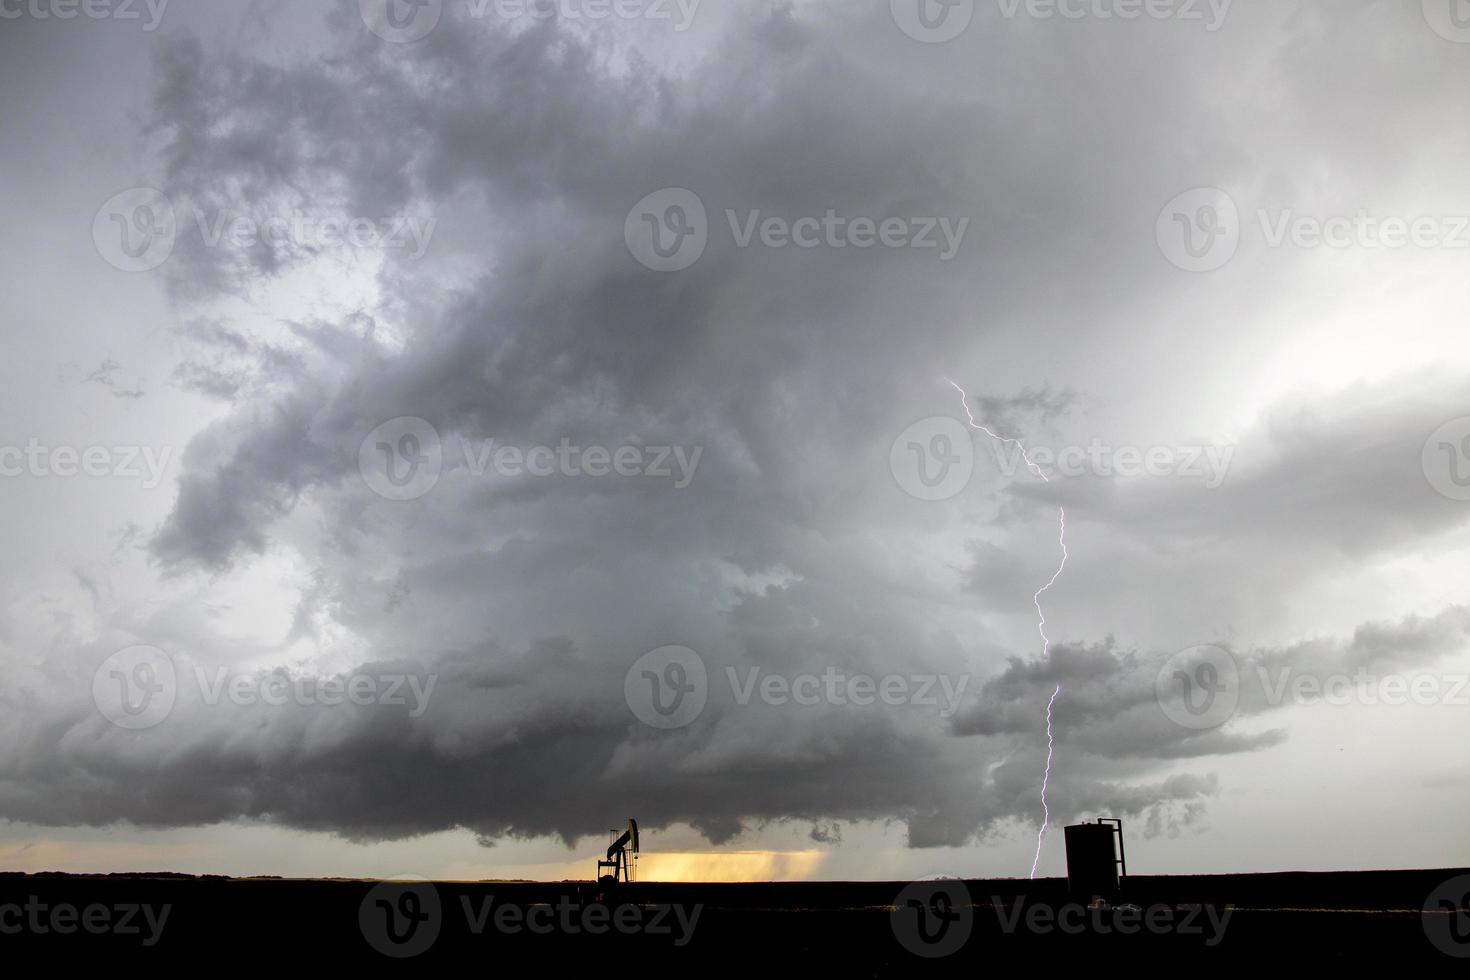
[0, 870, 1470, 977]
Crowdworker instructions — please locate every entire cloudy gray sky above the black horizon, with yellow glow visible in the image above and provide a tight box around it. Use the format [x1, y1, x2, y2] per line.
[0, 0, 1470, 879]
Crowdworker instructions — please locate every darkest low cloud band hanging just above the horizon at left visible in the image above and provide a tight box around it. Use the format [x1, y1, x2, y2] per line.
[0, 631, 1192, 845]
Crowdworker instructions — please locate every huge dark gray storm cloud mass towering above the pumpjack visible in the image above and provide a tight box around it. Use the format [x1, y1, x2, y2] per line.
[0, 3, 1464, 846]
